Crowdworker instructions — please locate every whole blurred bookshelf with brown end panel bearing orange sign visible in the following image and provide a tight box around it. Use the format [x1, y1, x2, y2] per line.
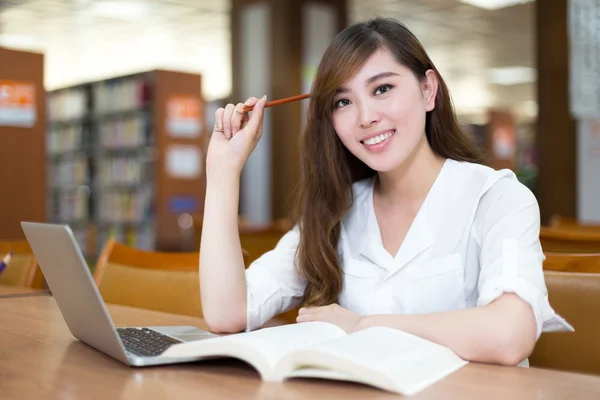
[48, 70, 205, 258]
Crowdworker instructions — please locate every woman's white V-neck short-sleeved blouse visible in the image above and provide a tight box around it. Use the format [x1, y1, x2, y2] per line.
[246, 159, 573, 337]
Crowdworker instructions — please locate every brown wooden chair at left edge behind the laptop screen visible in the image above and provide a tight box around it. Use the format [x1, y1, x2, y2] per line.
[0, 240, 46, 289]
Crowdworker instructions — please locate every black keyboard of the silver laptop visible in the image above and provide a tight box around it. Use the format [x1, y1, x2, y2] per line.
[117, 328, 181, 357]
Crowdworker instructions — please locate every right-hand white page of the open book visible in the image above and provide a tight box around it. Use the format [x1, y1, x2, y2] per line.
[277, 327, 467, 395]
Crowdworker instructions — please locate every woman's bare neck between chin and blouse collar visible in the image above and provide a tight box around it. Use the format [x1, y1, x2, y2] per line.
[375, 138, 446, 204]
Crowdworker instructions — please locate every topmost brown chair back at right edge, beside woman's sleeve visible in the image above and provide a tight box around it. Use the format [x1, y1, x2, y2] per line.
[540, 226, 600, 253]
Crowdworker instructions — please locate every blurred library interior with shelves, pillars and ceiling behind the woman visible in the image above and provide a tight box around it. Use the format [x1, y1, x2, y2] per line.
[0, 0, 600, 264]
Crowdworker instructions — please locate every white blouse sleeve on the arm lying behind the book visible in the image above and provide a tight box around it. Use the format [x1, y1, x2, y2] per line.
[474, 178, 573, 337]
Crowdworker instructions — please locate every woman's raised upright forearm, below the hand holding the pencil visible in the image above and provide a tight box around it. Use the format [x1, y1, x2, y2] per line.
[200, 171, 246, 332]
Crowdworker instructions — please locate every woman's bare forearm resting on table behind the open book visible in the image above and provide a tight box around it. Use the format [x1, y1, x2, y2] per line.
[358, 294, 536, 365]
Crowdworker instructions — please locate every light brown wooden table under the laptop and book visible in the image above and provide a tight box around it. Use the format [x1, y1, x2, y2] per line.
[0, 296, 600, 400]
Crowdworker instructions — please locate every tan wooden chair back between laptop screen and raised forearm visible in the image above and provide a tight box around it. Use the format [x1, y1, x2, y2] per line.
[94, 239, 202, 317]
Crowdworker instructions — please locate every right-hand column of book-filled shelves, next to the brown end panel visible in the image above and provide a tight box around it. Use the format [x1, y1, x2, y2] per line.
[92, 74, 156, 255]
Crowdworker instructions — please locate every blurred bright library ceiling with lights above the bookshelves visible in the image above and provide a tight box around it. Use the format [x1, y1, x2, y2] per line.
[0, 0, 536, 122]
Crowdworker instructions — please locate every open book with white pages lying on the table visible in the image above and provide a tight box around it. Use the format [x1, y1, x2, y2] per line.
[160, 322, 467, 395]
